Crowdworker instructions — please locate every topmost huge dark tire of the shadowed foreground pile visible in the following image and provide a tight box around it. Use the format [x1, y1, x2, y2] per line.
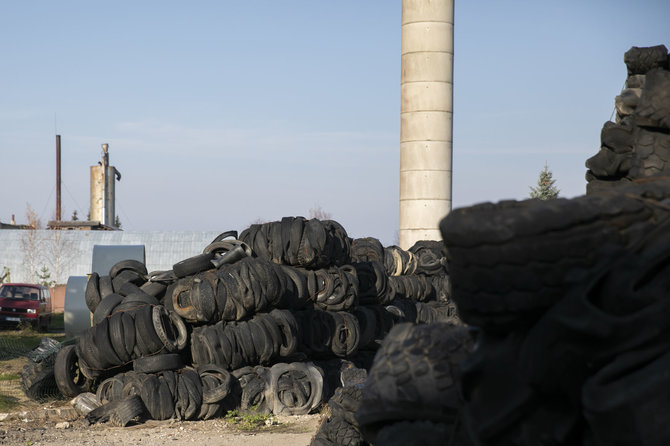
[440, 183, 667, 330]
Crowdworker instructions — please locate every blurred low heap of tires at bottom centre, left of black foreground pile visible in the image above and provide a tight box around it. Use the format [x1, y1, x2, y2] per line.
[350, 322, 474, 446]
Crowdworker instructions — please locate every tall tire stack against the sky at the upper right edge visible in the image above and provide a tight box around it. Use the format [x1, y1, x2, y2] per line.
[586, 45, 670, 193]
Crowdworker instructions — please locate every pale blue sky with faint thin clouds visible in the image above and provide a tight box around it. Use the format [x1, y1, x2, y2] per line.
[0, 0, 670, 245]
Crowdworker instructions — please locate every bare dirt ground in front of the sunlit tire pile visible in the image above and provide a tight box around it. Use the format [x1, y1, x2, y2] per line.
[0, 405, 324, 446]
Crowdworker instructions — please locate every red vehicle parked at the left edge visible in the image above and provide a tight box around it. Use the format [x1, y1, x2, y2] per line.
[0, 283, 51, 331]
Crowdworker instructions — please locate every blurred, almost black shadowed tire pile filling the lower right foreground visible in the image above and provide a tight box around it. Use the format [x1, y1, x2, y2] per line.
[440, 177, 670, 445]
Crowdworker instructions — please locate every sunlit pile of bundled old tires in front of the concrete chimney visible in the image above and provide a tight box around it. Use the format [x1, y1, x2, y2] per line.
[48, 217, 459, 425]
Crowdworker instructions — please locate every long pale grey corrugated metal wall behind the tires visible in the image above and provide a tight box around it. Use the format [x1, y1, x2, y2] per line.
[0, 229, 219, 284]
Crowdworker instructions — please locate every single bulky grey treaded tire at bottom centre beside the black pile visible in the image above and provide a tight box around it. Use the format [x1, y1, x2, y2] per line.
[356, 323, 474, 438]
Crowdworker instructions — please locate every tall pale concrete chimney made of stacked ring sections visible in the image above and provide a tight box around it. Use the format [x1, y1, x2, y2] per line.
[399, 0, 454, 249]
